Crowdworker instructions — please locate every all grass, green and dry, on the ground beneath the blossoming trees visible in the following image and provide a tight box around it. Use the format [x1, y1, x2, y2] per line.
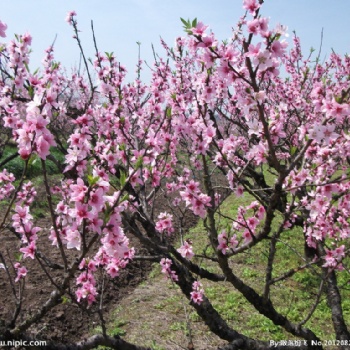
[5, 144, 350, 344]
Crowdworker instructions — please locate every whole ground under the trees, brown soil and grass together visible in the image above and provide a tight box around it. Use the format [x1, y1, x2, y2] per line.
[0, 148, 350, 350]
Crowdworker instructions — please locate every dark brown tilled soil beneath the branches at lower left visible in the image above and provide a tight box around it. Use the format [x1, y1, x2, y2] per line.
[0, 180, 200, 344]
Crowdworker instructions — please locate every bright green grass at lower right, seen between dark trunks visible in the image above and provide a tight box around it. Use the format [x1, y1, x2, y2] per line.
[186, 189, 350, 340]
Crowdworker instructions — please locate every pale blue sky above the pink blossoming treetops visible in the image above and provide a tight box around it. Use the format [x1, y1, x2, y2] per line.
[0, 0, 350, 80]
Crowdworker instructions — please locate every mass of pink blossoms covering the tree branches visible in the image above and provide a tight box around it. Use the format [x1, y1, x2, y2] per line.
[0, 0, 350, 318]
